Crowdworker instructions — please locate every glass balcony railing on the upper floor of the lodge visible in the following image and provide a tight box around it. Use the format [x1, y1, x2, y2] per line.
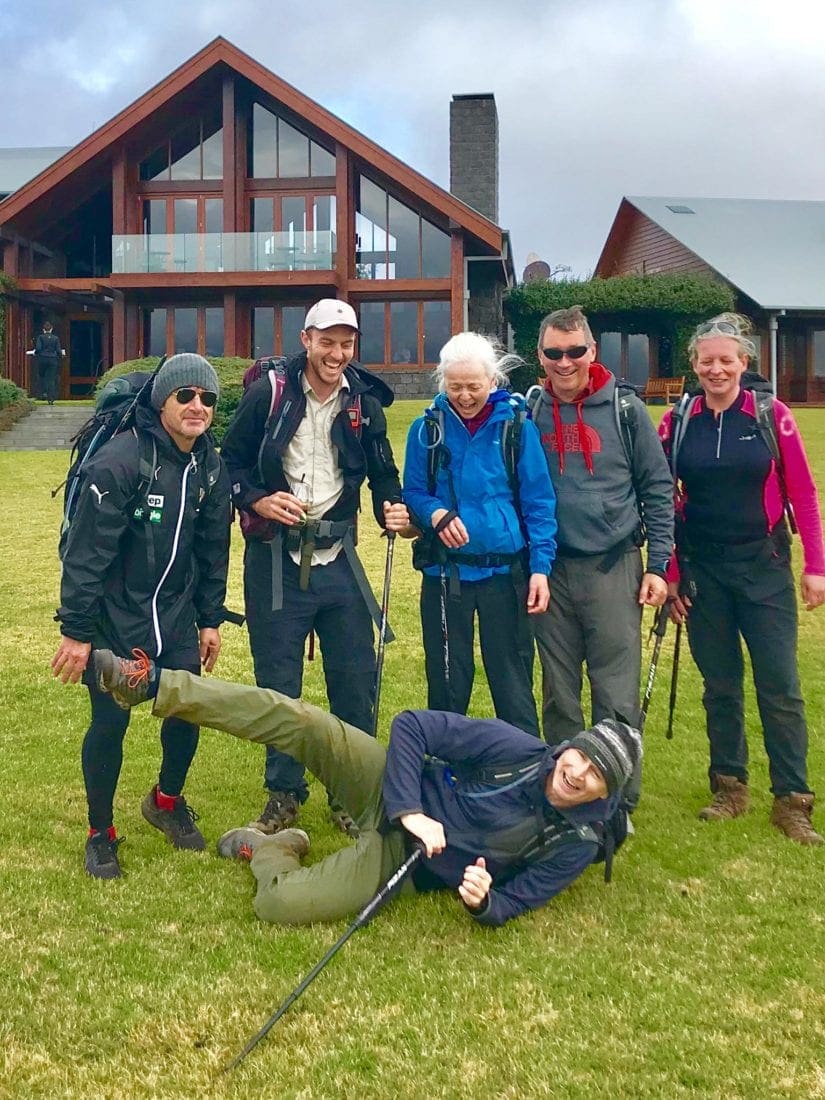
[112, 230, 336, 275]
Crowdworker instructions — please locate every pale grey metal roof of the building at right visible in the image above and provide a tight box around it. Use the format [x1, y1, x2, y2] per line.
[627, 195, 825, 309]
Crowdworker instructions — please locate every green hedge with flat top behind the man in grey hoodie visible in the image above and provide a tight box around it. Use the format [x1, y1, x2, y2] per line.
[505, 274, 735, 391]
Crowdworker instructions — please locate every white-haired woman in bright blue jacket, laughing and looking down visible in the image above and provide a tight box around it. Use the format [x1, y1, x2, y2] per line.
[404, 332, 556, 736]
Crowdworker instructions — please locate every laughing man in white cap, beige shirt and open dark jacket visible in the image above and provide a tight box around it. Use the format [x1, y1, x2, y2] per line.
[221, 298, 409, 833]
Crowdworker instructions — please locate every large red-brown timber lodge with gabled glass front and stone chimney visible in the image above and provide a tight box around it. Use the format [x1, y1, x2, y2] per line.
[0, 37, 514, 397]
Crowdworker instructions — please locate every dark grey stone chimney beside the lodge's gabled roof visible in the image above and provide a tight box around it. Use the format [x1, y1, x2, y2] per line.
[450, 91, 498, 223]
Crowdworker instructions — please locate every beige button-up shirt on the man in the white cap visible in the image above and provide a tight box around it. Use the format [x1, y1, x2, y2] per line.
[282, 372, 350, 565]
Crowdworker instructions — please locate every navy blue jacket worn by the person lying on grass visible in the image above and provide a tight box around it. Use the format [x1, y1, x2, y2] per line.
[384, 711, 618, 925]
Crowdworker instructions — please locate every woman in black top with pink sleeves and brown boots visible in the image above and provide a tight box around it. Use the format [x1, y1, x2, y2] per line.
[659, 314, 825, 844]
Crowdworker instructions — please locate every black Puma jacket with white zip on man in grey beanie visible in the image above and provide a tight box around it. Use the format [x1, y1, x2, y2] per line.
[57, 407, 231, 658]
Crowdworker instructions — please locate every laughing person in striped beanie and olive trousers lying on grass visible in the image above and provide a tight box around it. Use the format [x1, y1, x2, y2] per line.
[94, 649, 641, 925]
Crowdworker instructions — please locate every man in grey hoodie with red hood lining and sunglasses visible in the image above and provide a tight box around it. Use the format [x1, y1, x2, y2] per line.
[531, 306, 673, 801]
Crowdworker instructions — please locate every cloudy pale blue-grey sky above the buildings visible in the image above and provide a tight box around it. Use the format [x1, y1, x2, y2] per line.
[0, 0, 825, 275]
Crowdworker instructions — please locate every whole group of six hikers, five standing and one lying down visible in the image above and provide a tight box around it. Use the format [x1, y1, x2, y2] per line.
[52, 299, 825, 924]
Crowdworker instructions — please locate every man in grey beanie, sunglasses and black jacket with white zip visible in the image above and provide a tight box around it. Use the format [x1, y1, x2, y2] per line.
[52, 352, 230, 879]
